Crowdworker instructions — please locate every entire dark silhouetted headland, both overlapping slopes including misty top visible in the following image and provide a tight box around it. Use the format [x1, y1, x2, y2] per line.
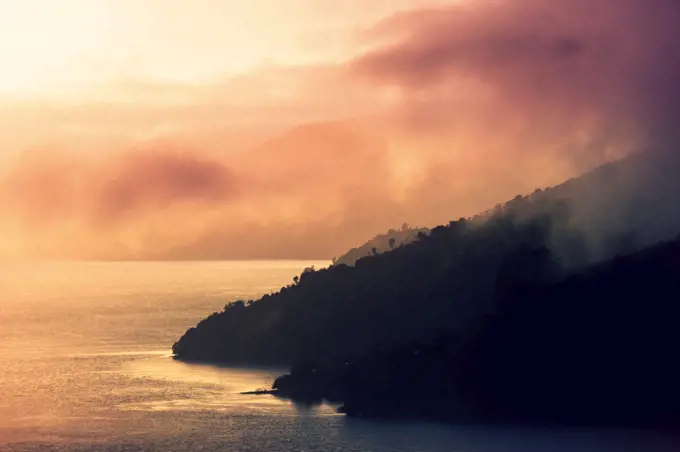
[173, 152, 680, 423]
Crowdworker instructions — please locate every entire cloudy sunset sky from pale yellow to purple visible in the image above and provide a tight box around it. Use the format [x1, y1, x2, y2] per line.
[0, 0, 680, 259]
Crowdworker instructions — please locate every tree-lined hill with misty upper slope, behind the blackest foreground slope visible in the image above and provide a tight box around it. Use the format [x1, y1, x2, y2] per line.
[173, 149, 680, 364]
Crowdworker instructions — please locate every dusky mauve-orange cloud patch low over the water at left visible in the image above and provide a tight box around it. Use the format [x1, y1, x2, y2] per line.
[0, 148, 238, 228]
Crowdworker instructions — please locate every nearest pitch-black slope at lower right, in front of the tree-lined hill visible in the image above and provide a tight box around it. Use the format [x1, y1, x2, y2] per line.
[274, 239, 680, 426]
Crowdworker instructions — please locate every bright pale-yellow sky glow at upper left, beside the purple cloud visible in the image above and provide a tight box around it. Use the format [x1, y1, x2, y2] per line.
[0, 0, 454, 96]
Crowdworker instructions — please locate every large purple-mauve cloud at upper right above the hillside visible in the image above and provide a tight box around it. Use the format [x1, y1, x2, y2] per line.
[353, 0, 680, 161]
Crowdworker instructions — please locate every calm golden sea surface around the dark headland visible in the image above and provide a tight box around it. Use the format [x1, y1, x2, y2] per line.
[0, 261, 680, 452]
